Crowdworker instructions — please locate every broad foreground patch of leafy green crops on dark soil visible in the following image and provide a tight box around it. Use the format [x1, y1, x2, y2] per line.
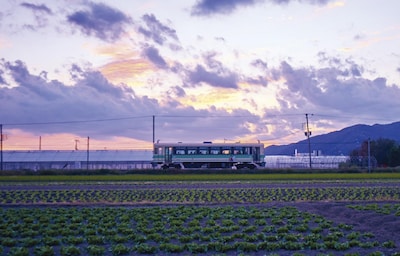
[0, 206, 399, 255]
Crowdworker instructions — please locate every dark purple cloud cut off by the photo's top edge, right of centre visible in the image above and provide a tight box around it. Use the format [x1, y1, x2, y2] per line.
[191, 0, 331, 16]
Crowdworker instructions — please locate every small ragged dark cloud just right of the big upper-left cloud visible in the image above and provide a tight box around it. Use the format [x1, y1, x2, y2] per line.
[138, 14, 178, 45]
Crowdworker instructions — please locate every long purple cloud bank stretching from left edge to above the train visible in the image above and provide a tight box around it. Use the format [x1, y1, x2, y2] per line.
[0, 61, 259, 142]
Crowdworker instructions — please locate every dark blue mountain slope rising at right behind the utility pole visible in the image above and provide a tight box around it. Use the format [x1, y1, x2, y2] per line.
[265, 122, 400, 155]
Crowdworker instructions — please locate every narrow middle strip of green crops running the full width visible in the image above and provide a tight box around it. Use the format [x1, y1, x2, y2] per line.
[0, 187, 400, 204]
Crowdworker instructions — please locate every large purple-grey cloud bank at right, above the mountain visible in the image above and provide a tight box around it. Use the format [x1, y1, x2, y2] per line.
[278, 62, 400, 120]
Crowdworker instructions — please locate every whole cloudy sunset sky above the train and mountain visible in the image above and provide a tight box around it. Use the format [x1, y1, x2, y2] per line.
[0, 0, 400, 150]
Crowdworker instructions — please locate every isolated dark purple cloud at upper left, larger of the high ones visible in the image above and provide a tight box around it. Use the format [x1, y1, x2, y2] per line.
[67, 2, 131, 41]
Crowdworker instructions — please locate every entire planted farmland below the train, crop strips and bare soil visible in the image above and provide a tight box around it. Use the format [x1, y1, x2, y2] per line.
[0, 174, 400, 255]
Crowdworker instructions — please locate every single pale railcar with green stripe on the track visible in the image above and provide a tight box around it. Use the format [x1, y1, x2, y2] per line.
[153, 142, 265, 169]
